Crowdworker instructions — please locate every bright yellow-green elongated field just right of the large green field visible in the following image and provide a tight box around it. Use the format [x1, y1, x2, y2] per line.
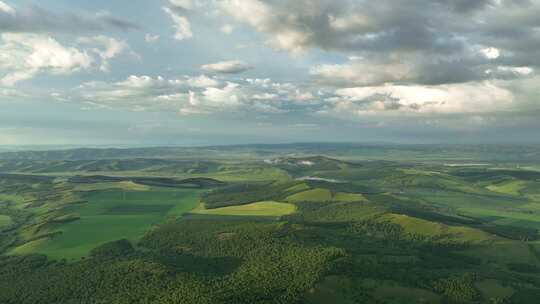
[192, 202, 296, 217]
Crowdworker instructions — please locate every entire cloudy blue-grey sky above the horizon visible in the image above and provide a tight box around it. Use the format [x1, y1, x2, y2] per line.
[0, 0, 540, 145]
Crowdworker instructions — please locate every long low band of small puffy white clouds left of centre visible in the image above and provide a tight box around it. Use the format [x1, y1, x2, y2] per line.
[69, 75, 317, 115]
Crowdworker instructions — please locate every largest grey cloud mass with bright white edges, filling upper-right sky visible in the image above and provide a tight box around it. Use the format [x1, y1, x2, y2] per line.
[219, 0, 540, 86]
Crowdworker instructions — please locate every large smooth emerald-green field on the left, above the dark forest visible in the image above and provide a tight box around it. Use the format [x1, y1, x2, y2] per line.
[12, 188, 199, 259]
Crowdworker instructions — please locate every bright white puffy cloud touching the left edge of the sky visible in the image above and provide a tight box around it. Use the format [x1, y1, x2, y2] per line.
[0, 33, 126, 86]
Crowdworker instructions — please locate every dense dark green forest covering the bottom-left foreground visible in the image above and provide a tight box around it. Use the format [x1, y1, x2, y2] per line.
[0, 221, 344, 304]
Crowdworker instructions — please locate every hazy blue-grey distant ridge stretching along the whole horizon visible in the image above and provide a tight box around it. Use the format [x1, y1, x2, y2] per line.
[0, 143, 540, 162]
